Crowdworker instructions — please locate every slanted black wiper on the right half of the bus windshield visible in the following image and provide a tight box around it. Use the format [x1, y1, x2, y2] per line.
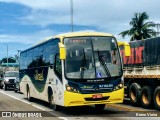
[98, 50, 111, 77]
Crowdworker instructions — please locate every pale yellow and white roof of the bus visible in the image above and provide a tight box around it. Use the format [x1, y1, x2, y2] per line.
[22, 31, 113, 52]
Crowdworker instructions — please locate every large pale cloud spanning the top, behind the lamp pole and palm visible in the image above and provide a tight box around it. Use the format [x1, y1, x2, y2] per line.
[0, 0, 160, 35]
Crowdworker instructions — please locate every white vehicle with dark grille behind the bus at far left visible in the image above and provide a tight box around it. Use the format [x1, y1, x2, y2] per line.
[2, 71, 19, 90]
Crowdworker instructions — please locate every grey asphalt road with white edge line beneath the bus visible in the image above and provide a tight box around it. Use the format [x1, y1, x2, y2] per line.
[0, 89, 160, 120]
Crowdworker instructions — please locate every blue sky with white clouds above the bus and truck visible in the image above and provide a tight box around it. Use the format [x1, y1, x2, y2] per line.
[0, 0, 160, 59]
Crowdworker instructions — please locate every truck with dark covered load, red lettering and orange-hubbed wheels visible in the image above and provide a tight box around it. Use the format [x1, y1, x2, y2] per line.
[120, 37, 160, 110]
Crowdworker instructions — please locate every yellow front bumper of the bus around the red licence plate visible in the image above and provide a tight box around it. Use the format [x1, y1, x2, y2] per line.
[64, 88, 124, 107]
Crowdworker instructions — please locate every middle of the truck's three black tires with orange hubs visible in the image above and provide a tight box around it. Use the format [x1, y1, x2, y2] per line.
[141, 86, 152, 108]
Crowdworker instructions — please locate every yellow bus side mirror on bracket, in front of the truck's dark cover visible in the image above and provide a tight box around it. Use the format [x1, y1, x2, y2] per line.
[118, 42, 131, 57]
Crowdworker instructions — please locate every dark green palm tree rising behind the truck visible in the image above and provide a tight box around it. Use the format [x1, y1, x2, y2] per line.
[119, 12, 156, 41]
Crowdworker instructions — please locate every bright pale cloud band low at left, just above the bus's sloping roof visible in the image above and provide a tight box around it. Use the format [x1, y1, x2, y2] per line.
[0, 29, 60, 58]
